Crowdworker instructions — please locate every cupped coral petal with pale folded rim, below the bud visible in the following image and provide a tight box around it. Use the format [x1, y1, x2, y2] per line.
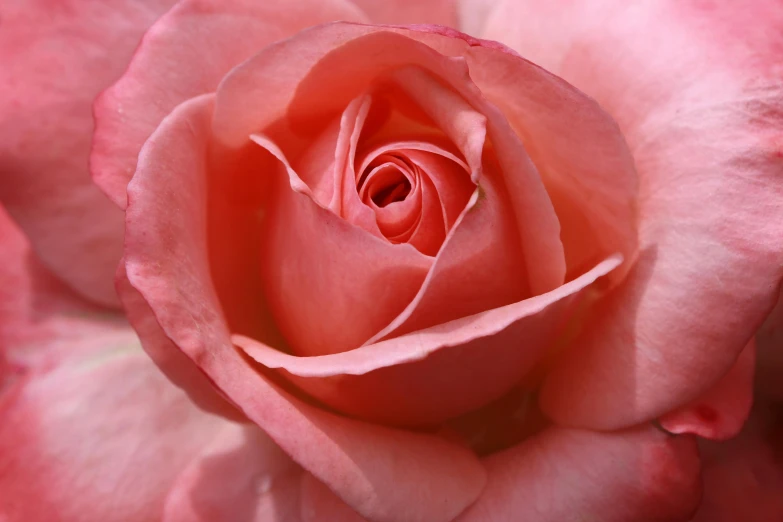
[233, 254, 620, 425]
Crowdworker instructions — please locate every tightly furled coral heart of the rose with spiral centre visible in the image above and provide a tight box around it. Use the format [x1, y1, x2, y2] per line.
[296, 80, 484, 256]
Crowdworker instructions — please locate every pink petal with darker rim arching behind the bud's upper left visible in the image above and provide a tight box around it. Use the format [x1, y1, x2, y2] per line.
[90, 0, 364, 208]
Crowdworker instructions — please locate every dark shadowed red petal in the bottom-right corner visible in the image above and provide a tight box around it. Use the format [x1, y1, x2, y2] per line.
[691, 404, 783, 522]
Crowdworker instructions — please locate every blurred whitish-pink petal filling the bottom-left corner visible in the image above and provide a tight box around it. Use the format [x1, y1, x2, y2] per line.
[0, 328, 225, 522]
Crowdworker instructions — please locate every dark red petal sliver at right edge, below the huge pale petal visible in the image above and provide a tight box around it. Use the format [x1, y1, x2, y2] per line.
[756, 286, 783, 403]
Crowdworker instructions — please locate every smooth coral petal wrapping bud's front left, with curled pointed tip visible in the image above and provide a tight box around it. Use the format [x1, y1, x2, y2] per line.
[253, 132, 432, 355]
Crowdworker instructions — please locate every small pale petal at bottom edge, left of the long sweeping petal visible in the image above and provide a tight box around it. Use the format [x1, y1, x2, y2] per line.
[163, 423, 305, 522]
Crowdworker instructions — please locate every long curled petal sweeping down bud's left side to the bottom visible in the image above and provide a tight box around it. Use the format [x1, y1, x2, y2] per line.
[126, 97, 484, 522]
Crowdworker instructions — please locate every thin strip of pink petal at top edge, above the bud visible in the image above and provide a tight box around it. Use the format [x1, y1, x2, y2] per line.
[351, 0, 457, 27]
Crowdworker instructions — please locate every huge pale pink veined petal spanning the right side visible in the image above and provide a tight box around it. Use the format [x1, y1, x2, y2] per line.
[462, 0, 783, 429]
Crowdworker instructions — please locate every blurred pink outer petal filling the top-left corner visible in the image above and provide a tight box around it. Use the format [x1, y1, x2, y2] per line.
[0, 0, 174, 305]
